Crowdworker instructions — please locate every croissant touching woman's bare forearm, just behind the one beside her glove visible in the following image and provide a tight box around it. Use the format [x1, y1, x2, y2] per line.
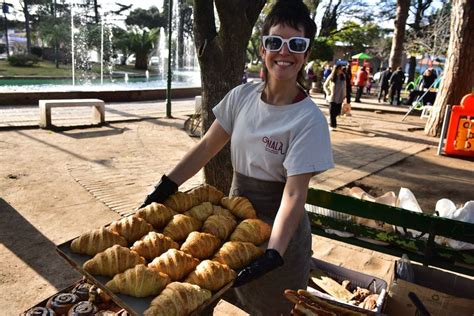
[230, 218, 272, 246]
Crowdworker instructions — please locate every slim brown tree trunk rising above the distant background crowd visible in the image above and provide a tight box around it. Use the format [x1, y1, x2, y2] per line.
[390, 0, 410, 71]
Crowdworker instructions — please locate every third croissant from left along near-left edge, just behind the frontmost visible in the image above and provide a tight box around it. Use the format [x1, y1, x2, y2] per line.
[105, 264, 171, 297]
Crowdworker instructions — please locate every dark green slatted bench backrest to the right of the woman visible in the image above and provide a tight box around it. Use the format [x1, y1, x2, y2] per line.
[306, 188, 474, 276]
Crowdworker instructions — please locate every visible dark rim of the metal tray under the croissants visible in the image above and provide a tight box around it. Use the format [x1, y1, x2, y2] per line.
[56, 239, 234, 316]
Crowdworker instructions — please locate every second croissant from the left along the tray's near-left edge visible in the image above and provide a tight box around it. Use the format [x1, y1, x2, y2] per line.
[83, 245, 145, 277]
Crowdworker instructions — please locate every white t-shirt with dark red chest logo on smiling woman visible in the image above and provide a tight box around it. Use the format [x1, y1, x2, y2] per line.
[213, 83, 334, 182]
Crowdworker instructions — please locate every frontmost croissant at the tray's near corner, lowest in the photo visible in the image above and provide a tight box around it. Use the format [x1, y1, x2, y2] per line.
[143, 282, 212, 316]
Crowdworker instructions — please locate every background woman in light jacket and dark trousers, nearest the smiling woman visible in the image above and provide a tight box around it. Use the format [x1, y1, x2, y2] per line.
[323, 65, 346, 130]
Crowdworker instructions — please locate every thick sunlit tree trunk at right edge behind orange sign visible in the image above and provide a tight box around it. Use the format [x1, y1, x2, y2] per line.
[425, 0, 474, 136]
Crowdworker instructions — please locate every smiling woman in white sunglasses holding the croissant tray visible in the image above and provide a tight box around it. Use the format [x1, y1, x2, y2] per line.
[140, 0, 333, 315]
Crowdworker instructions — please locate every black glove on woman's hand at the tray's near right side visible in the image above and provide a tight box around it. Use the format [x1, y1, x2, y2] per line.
[234, 249, 283, 287]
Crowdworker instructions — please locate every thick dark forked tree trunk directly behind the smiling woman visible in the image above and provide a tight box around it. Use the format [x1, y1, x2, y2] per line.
[194, 0, 265, 193]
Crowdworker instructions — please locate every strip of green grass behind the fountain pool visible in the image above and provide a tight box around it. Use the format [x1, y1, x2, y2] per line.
[0, 60, 161, 77]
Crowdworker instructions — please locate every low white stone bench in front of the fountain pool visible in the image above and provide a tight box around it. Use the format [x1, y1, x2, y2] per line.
[39, 99, 105, 128]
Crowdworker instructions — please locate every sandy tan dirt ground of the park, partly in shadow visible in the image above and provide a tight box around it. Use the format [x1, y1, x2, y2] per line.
[0, 105, 474, 315]
